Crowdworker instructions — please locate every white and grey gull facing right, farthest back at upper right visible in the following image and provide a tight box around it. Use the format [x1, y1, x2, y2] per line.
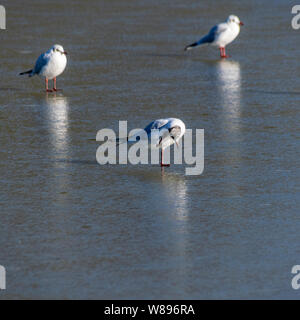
[184, 15, 244, 58]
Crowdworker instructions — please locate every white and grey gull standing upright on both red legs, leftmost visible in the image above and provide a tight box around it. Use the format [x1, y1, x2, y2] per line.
[20, 44, 67, 92]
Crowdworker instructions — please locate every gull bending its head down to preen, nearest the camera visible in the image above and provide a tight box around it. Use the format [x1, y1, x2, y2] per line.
[117, 118, 185, 167]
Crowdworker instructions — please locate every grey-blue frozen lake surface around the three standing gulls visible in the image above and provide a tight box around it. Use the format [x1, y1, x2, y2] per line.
[0, 0, 300, 299]
